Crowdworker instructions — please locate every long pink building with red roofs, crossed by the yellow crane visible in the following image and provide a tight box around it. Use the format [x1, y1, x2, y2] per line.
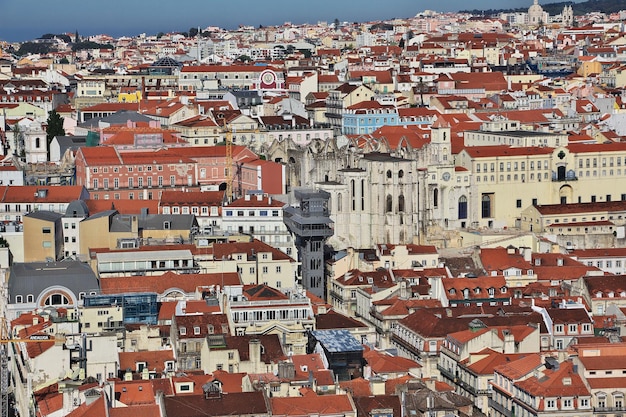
[76, 145, 286, 200]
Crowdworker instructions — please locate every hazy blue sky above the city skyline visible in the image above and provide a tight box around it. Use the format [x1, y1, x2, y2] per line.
[0, 0, 544, 42]
